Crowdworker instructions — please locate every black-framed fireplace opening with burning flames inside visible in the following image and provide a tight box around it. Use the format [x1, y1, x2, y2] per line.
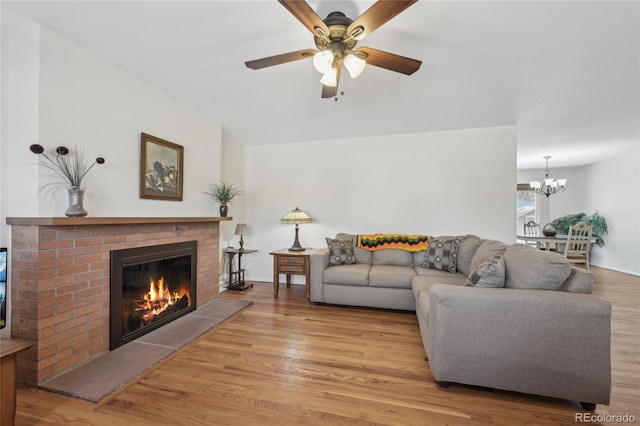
[109, 241, 197, 350]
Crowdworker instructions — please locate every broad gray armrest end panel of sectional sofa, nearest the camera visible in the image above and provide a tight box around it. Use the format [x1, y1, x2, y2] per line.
[428, 284, 611, 404]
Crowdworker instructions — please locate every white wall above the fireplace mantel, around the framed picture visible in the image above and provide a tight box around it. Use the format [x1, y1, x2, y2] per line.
[3, 25, 221, 223]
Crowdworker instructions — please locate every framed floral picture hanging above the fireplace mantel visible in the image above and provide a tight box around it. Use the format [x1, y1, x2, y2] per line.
[140, 133, 184, 201]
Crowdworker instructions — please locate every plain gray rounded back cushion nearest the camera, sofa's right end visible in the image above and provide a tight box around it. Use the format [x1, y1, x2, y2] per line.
[504, 244, 571, 290]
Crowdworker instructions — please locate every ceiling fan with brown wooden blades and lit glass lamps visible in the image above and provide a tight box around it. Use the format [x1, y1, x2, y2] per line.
[245, 0, 422, 100]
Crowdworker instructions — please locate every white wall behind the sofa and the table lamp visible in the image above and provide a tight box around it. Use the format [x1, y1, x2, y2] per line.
[243, 126, 517, 281]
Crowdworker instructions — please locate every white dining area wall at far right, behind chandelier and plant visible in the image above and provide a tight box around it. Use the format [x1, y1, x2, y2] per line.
[518, 151, 640, 275]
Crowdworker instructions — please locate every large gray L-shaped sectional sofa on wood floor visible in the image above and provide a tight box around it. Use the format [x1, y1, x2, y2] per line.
[310, 234, 611, 409]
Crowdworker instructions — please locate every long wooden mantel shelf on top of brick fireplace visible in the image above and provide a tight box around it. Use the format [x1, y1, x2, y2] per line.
[7, 216, 233, 226]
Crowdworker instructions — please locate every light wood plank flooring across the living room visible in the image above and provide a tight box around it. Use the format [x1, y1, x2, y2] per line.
[11, 267, 640, 426]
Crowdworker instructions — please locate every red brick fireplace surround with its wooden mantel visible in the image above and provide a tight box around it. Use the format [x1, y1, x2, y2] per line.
[7, 217, 231, 384]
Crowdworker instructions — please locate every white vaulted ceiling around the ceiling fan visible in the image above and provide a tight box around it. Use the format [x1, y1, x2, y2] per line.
[0, 0, 640, 169]
